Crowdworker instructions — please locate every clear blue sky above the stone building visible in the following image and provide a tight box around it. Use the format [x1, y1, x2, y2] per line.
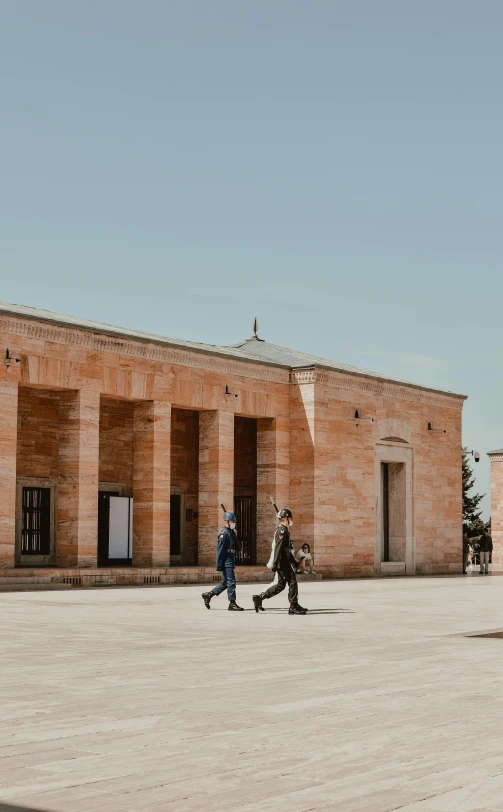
[0, 0, 503, 513]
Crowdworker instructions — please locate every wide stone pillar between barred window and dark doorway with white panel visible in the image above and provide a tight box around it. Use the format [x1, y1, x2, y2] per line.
[56, 389, 100, 568]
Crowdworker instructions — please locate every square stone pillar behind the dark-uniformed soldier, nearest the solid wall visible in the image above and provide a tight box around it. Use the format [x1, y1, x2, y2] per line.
[257, 418, 295, 564]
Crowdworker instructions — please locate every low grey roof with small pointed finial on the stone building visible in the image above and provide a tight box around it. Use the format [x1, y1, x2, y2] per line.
[0, 302, 468, 400]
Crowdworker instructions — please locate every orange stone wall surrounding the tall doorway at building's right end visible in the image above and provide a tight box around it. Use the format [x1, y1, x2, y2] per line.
[304, 373, 462, 576]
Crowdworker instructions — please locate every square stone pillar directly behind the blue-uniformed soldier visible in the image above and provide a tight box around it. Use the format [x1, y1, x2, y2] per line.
[198, 409, 234, 566]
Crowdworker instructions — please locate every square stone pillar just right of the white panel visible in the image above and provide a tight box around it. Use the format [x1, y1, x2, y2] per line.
[133, 400, 171, 567]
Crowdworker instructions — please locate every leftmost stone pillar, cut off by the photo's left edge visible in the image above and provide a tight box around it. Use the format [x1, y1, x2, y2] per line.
[0, 380, 18, 568]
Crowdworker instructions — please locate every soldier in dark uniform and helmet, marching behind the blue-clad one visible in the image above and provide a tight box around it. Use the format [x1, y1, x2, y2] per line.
[253, 508, 307, 615]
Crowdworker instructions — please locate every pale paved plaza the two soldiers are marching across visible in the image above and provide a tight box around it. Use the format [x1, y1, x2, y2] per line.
[0, 576, 503, 812]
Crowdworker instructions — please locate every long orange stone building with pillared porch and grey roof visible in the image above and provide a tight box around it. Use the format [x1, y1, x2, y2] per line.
[0, 304, 464, 584]
